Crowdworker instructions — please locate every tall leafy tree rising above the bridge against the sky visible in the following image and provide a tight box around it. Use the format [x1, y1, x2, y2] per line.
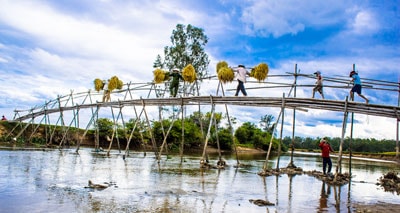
[153, 24, 210, 78]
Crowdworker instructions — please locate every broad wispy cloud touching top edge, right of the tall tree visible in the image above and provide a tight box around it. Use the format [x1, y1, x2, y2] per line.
[241, 0, 345, 37]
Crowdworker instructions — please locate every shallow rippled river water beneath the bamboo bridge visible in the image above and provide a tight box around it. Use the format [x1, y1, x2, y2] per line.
[0, 149, 400, 213]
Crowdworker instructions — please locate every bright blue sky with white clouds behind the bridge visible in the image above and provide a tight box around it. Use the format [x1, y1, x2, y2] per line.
[0, 0, 400, 139]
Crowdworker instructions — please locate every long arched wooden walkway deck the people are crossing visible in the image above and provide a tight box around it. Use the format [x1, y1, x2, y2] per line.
[16, 96, 400, 121]
